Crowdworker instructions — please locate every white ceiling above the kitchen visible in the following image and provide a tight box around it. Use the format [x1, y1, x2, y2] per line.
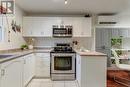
[15, 0, 130, 14]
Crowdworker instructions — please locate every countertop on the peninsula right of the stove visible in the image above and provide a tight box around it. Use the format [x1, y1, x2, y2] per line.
[76, 50, 107, 56]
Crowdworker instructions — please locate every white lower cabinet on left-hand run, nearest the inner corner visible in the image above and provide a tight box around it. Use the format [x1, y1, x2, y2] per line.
[23, 54, 35, 86]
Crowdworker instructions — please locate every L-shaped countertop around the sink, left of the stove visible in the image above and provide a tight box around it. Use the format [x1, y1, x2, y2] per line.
[0, 49, 52, 63]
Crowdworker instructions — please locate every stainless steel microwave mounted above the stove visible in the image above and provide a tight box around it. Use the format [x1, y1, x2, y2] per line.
[53, 25, 73, 38]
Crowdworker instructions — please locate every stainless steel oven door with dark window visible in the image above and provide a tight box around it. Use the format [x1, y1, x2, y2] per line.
[51, 53, 75, 74]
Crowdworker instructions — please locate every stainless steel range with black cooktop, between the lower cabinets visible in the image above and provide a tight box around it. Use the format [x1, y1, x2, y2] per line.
[51, 43, 76, 80]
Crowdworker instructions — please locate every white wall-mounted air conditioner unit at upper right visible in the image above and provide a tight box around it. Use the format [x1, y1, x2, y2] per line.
[98, 15, 117, 25]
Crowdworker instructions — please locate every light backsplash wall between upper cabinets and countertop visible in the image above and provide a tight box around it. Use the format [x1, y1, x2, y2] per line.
[30, 37, 94, 50]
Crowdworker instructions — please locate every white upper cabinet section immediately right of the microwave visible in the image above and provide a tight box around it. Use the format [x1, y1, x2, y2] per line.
[73, 17, 92, 37]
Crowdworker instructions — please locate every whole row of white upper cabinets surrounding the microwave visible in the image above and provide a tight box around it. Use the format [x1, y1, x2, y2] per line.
[23, 17, 91, 37]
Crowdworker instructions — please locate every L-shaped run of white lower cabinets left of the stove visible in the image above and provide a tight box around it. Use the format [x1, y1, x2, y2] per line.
[0, 53, 50, 87]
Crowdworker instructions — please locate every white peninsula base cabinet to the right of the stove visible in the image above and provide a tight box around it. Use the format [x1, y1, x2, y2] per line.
[76, 54, 107, 87]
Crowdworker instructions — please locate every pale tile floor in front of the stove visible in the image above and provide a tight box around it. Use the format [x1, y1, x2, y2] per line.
[27, 79, 78, 87]
